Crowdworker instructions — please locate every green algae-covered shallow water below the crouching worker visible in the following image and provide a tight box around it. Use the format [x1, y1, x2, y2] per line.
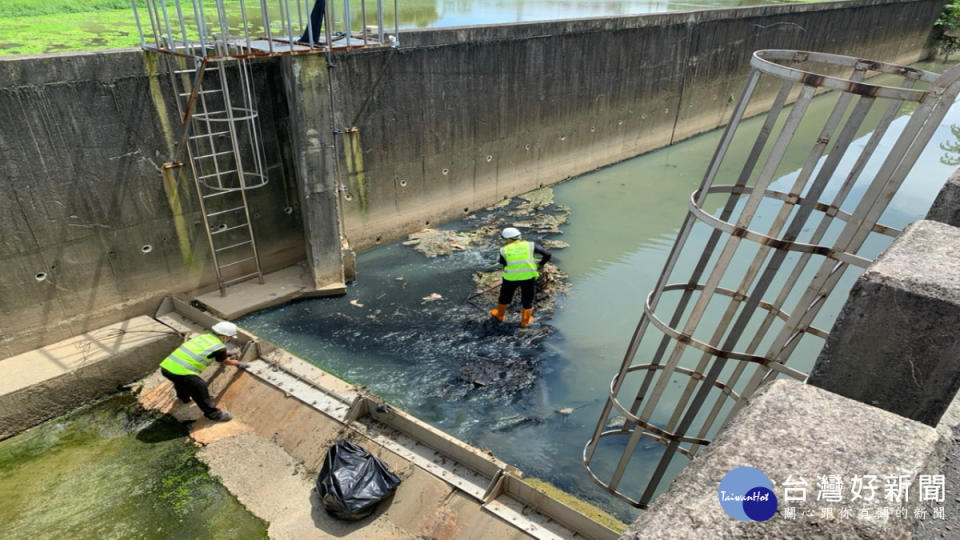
[0, 394, 267, 539]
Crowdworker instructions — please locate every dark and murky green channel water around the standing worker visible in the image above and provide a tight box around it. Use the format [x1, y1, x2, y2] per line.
[240, 60, 960, 520]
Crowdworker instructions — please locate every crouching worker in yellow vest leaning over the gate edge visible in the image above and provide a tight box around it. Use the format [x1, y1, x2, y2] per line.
[160, 321, 247, 422]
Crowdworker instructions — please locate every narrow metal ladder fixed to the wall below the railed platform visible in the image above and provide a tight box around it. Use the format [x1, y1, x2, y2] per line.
[172, 57, 267, 296]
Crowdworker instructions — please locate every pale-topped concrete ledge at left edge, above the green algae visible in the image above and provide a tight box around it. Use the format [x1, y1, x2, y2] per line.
[0, 317, 181, 439]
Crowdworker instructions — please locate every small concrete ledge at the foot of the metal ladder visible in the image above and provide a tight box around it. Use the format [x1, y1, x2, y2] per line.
[196, 263, 347, 321]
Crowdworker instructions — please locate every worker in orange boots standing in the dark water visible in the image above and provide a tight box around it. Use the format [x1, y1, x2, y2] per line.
[490, 227, 550, 328]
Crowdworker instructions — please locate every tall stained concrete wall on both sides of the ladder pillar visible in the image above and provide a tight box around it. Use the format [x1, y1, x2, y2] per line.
[0, 0, 944, 358]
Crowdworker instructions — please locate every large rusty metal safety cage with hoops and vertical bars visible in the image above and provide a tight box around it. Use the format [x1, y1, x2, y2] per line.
[583, 50, 960, 508]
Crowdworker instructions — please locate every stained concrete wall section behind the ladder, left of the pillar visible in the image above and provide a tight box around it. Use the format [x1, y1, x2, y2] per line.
[0, 51, 303, 358]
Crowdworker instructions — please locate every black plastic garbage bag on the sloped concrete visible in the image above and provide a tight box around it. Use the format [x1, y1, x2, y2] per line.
[317, 439, 400, 521]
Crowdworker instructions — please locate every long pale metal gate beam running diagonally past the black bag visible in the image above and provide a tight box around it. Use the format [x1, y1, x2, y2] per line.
[156, 299, 618, 539]
